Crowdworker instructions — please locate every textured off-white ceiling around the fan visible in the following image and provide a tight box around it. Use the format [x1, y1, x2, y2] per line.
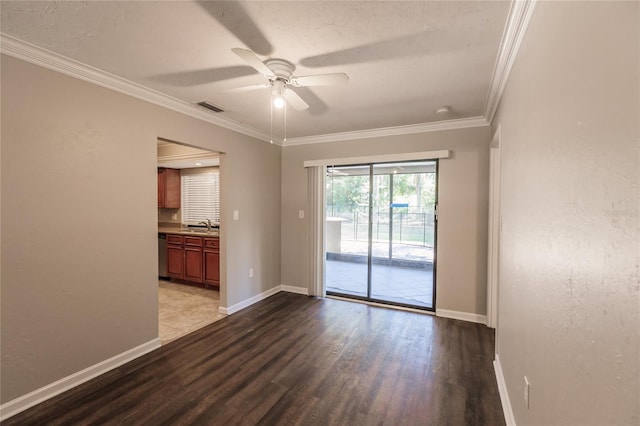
[0, 1, 510, 138]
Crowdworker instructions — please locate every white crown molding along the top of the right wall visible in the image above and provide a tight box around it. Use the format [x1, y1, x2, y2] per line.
[484, 0, 537, 123]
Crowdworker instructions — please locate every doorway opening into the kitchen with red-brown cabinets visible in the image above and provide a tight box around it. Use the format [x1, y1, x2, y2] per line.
[157, 139, 226, 345]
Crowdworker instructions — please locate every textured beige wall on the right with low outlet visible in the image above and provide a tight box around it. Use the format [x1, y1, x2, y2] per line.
[495, 2, 640, 426]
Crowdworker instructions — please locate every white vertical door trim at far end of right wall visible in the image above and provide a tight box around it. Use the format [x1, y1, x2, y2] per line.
[487, 127, 501, 328]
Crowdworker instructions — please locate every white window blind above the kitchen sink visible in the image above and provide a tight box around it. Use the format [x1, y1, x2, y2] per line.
[180, 170, 220, 225]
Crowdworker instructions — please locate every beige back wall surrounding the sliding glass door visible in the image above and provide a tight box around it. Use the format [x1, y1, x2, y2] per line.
[281, 127, 490, 315]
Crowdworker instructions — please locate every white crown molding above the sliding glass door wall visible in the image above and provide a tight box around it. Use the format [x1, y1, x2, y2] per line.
[283, 117, 489, 147]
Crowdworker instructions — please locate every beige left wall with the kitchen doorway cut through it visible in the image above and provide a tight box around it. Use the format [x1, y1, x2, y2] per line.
[1, 56, 281, 403]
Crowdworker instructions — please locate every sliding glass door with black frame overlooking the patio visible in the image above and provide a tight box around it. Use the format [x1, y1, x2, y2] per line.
[324, 160, 438, 311]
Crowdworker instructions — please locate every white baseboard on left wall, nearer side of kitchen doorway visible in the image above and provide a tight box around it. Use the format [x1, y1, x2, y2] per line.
[0, 338, 160, 421]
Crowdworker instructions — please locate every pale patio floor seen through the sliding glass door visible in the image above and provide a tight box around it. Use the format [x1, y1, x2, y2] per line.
[325, 260, 433, 308]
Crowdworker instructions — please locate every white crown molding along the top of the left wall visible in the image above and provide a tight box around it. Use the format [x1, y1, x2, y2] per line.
[0, 33, 270, 142]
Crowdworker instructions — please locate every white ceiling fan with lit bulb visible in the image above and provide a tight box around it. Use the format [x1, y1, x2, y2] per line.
[229, 48, 349, 111]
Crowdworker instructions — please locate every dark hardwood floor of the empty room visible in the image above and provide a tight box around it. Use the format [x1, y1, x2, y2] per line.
[2, 293, 504, 426]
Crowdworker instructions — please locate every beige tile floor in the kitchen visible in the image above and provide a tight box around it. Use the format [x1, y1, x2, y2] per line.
[158, 280, 226, 345]
